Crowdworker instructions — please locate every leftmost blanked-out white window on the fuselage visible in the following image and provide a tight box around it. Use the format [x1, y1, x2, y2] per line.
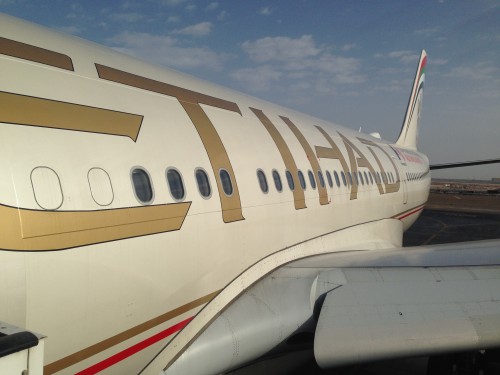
[31, 167, 63, 210]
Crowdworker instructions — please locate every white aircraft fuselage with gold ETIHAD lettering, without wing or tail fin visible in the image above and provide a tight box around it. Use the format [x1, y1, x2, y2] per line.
[0, 16, 430, 374]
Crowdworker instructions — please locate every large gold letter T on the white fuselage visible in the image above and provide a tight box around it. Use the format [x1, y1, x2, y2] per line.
[95, 64, 245, 223]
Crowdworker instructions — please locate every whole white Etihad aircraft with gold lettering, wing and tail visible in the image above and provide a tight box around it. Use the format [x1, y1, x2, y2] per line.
[0, 15, 500, 375]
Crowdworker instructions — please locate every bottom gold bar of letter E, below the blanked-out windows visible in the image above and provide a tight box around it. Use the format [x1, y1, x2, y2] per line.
[0, 202, 191, 251]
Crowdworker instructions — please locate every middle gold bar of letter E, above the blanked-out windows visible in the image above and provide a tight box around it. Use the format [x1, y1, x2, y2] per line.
[0, 92, 143, 142]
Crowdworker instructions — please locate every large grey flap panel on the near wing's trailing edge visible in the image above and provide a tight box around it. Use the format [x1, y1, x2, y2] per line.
[314, 266, 500, 368]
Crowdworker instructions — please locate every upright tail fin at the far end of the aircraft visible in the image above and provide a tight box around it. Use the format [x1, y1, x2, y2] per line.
[396, 50, 427, 149]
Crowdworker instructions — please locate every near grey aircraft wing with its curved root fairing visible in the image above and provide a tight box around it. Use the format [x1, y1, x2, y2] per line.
[157, 240, 500, 374]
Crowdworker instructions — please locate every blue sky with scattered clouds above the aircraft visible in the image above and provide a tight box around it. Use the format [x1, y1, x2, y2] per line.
[0, 0, 500, 180]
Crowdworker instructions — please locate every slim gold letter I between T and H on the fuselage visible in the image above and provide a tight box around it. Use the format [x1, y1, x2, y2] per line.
[250, 107, 307, 210]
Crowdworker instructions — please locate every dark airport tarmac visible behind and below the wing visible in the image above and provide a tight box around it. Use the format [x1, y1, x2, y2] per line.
[289, 193, 500, 375]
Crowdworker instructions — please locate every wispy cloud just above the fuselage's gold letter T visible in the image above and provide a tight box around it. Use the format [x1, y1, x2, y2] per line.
[108, 32, 226, 70]
